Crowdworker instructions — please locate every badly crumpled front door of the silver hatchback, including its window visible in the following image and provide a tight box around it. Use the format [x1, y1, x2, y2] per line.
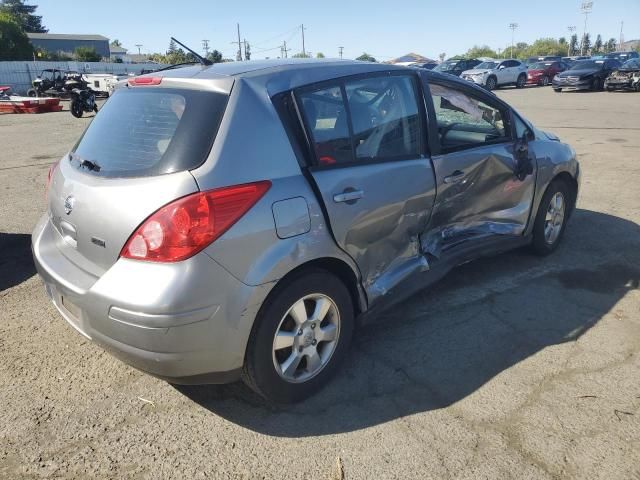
[423, 80, 536, 257]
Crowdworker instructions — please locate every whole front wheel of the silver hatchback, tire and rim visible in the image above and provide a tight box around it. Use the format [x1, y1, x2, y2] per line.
[531, 180, 573, 255]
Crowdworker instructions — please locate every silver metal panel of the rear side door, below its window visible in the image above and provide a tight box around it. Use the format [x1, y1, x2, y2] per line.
[313, 158, 435, 302]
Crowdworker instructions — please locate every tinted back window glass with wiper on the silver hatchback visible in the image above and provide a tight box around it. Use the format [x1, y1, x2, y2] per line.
[71, 87, 228, 177]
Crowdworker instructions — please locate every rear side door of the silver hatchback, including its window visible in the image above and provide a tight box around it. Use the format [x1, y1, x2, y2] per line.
[296, 72, 435, 301]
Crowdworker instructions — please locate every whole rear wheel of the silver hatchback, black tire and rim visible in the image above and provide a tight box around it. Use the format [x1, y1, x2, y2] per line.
[242, 270, 354, 403]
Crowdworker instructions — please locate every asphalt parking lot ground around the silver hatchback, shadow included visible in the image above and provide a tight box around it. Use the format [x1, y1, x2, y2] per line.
[0, 87, 640, 479]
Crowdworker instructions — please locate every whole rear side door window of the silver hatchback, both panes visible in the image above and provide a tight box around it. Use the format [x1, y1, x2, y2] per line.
[298, 75, 422, 165]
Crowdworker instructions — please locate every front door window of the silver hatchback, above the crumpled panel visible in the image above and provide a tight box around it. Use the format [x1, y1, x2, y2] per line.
[429, 83, 510, 151]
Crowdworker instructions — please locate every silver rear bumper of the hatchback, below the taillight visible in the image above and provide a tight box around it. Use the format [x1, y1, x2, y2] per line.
[32, 216, 263, 383]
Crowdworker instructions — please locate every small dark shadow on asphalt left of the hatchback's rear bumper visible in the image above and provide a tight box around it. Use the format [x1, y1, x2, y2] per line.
[0, 232, 36, 292]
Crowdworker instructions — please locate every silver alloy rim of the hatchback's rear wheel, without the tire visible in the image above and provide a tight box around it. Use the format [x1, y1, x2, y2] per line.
[273, 293, 340, 383]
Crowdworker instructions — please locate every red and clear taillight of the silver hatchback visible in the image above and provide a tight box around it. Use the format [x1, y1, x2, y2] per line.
[120, 181, 271, 262]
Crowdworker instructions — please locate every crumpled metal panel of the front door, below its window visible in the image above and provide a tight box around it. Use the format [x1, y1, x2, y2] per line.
[422, 144, 536, 257]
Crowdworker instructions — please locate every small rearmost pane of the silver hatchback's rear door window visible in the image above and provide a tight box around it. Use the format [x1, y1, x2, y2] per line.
[299, 86, 353, 165]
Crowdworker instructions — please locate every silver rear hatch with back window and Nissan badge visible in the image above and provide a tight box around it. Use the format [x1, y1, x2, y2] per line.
[48, 86, 228, 277]
